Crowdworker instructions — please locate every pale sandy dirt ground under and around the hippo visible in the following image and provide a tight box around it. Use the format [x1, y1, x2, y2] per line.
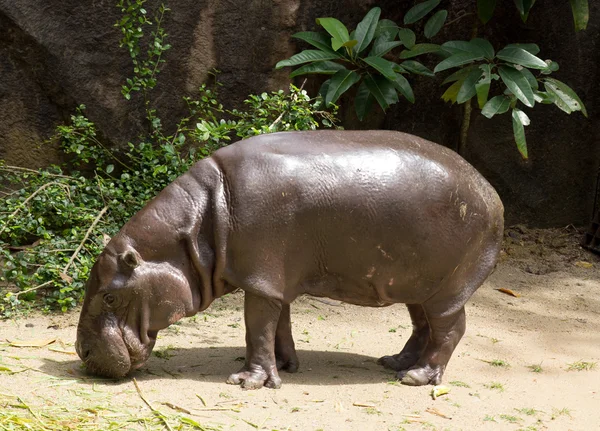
[0, 227, 600, 431]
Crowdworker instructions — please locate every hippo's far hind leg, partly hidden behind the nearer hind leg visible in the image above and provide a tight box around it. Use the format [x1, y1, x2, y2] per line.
[377, 304, 430, 371]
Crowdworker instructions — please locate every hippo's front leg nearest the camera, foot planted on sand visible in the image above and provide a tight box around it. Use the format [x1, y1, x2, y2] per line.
[227, 292, 282, 389]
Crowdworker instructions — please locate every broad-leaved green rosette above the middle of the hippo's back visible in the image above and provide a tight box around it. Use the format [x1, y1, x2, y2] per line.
[275, 6, 440, 120]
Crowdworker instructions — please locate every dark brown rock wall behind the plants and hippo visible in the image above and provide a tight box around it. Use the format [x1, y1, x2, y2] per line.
[0, 0, 600, 227]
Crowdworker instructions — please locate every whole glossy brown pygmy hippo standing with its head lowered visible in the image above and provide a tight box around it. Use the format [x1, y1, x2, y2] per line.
[76, 131, 503, 389]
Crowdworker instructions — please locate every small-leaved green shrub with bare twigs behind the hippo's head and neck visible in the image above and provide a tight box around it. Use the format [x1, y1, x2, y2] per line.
[0, 0, 337, 317]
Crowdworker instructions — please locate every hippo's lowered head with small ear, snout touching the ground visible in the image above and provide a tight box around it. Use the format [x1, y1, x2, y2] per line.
[75, 235, 198, 378]
